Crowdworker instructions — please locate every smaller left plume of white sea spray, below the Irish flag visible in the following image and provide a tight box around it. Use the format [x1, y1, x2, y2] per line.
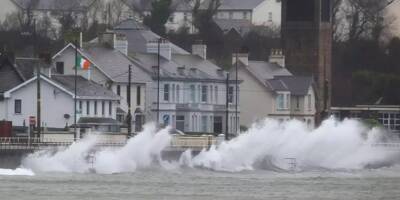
[22, 123, 171, 174]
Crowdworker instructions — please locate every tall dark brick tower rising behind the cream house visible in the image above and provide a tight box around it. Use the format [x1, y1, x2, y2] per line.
[282, 0, 332, 121]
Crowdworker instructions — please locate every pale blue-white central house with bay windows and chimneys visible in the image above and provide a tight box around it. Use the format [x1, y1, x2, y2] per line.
[134, 41, 240, 135]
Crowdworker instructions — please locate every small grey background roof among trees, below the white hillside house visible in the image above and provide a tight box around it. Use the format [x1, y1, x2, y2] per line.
[214, 19, 252, 36]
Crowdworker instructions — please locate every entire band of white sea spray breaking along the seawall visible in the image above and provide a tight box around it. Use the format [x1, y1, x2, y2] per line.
[21, 118, 400, 174]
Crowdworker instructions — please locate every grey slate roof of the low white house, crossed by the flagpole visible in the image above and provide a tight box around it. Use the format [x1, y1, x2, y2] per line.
[51, 75, 120, 100]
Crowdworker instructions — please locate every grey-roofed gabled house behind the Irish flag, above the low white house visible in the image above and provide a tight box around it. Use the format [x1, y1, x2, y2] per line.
[52, 32, 152, 131]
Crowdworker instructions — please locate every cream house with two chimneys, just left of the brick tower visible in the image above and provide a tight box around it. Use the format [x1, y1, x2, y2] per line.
[231, 50, 316, 127]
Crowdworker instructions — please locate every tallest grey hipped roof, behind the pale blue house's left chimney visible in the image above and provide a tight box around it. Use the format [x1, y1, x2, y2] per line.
[114, 19, 189, 54]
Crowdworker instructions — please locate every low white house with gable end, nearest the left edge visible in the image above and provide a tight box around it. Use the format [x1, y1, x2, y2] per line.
[2, 75, 119, 132]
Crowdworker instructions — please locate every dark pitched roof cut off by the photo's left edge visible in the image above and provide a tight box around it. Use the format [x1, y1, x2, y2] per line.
[0, 55, 24, 93]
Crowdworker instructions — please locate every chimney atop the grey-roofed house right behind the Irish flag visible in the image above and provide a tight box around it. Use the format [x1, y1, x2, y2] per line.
[99, 32, 128, 55]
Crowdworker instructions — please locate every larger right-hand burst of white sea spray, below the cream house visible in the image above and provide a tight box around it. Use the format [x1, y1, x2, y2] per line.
[181, 118, 399, 172]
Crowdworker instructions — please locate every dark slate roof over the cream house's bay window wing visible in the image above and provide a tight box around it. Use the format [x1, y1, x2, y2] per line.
[267, 76, 313, 96]
